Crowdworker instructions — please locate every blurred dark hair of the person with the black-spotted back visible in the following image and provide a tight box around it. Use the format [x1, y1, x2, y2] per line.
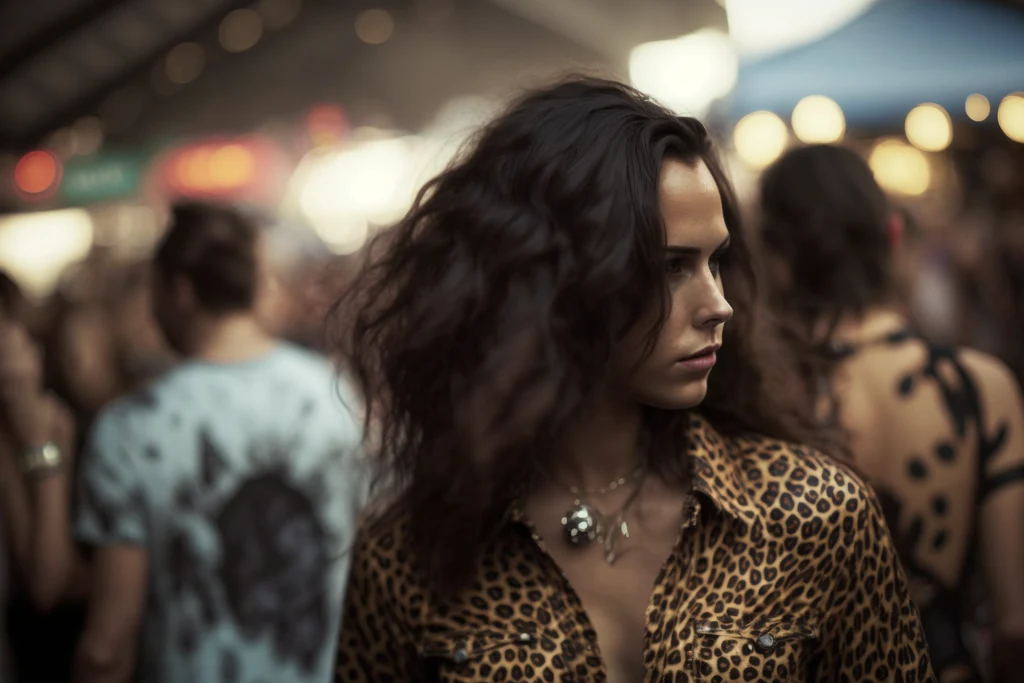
[759, 144, 897, 396]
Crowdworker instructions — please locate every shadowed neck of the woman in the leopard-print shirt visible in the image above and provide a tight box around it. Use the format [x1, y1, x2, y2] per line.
[543, 392, 643, 489]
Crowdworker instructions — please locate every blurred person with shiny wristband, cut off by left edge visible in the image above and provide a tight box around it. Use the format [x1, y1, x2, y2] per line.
[0, 270, 85, 681]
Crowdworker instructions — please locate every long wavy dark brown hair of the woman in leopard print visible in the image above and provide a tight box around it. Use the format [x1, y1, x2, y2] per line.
[334, 77, 836, 591]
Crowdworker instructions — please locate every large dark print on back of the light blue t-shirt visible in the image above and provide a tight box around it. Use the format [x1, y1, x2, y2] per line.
[157, 430, 339, 681]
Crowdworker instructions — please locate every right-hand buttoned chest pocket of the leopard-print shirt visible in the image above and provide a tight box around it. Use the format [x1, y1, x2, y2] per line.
[690, 616, 819, 683]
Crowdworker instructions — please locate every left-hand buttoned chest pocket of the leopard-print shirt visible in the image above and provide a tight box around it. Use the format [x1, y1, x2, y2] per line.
[419, 630, 546, 683]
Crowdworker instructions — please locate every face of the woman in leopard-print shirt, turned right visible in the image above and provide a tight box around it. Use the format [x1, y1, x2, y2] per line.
[611, 160, 732, 410]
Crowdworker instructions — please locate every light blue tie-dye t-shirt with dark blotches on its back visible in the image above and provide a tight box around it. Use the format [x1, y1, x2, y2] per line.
[76, 344, 366, 683]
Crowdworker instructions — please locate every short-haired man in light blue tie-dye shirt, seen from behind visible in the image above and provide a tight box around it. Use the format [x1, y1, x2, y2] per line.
[70, 204, 362, 683]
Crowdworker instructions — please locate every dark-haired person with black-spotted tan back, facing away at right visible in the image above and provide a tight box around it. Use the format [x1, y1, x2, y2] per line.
[760, 145, 1024, 683]
